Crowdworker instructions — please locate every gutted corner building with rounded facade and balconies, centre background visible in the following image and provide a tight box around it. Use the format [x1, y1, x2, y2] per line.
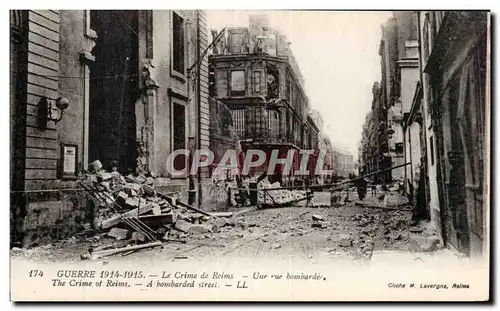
[209, 15, 318, 183]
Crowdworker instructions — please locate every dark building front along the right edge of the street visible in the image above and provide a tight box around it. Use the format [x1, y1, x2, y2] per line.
[414, 11, 491, 256]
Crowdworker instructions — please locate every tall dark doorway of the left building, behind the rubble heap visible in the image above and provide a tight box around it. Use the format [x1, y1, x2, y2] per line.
[89, 10, 139, 174]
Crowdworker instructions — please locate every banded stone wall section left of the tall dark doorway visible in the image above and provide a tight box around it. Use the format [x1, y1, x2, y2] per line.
[23, 11, 94, 246]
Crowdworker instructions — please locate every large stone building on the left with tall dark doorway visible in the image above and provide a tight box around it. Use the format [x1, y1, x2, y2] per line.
[10, 10, 210, 244]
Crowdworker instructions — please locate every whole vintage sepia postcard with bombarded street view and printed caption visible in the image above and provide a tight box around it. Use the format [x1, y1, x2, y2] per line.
[6, 9, 492, 301]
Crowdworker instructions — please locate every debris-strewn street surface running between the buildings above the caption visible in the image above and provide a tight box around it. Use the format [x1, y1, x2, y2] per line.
[12, 192, 450, 264]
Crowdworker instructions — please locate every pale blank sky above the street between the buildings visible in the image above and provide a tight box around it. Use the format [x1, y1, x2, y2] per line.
[207, 10, 392, 160]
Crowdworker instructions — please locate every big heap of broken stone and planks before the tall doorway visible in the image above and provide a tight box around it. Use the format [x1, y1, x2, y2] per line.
[82, 161, 233, 260]
